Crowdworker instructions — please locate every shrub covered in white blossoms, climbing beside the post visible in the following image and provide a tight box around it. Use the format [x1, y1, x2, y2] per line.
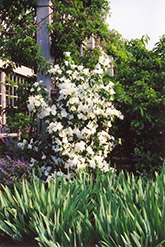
[23, 53, 123, 177]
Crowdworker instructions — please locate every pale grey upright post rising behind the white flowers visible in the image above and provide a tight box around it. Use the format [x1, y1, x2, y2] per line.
[36, 0, 51, 95]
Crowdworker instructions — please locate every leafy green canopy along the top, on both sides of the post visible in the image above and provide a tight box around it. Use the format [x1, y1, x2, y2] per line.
[0, 0, 109, 68]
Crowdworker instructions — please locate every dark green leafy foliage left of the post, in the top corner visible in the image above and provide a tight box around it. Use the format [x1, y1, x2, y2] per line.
[0, 0, 42, 68]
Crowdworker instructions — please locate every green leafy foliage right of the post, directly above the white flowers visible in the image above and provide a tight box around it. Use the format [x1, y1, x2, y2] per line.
[49, 0, 109, 63]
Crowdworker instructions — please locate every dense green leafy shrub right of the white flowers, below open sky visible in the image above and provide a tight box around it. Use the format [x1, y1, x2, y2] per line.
[109, 36, 165, 174]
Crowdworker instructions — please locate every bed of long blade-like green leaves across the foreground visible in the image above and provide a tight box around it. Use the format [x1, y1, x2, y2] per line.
[0, 169, 165, 247]
